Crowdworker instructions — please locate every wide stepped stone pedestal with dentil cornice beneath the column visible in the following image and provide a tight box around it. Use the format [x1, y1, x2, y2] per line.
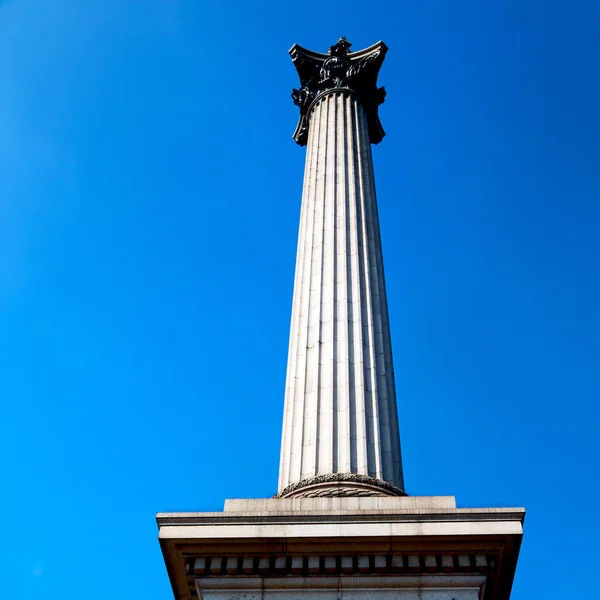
[157, 497, 524, 600]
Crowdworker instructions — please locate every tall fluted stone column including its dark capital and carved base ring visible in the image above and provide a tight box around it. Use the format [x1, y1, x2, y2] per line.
[278, 38, 404, 497]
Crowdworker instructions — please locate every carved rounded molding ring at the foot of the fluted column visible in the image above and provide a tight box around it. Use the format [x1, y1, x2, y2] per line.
[275, 473, 407, 498]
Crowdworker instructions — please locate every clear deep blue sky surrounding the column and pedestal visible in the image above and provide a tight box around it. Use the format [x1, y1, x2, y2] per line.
[0, 0, 600, 600]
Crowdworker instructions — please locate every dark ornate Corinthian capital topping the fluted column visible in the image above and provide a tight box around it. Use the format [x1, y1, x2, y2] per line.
[290, 37, 387, 146]
